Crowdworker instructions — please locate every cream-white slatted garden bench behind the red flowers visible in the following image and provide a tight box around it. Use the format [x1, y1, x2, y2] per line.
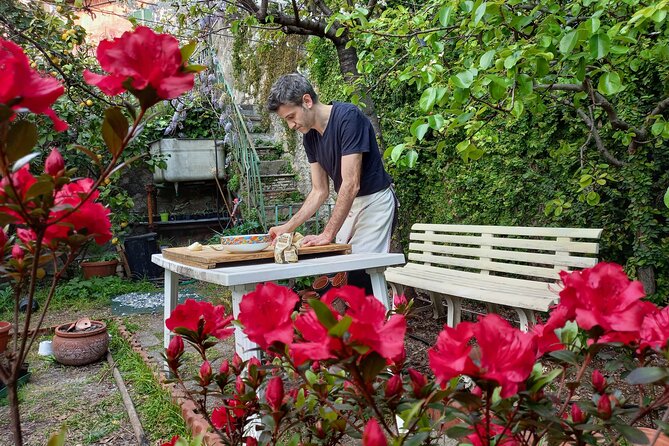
[385, 223, 602, 330]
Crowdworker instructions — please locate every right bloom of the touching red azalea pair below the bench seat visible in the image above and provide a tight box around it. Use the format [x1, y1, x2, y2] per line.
[473, 314, 537, 398]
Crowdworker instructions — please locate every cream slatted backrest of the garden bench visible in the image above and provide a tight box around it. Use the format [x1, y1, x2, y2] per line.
[409, 223, 602, 282]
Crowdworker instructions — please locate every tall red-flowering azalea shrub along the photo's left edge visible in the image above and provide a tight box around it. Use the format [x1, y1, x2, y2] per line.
[0, 27, 200, 445]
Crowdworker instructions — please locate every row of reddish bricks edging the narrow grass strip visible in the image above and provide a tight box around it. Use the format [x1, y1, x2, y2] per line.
[116, 319, 224, 446]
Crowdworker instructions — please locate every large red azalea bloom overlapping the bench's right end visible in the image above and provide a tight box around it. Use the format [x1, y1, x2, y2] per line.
[559, 262, 657, 344]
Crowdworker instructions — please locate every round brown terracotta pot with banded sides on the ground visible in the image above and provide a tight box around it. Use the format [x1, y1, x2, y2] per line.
[51, 321, 109, 365]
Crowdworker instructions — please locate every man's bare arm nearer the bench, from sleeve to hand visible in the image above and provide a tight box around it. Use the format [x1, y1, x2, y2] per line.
[302, 153, 362, 246]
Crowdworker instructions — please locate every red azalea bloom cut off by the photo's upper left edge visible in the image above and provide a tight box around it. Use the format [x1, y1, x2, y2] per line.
[0, 38, 67, 132]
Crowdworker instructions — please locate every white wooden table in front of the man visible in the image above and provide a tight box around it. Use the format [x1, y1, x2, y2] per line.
[151, 253, 404, 359]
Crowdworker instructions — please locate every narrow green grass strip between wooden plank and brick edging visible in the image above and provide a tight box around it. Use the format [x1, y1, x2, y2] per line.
[108, 322, 189, 444]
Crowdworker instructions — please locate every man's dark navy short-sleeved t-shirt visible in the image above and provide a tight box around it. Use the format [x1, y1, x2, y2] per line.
[304, 102, 391, 197]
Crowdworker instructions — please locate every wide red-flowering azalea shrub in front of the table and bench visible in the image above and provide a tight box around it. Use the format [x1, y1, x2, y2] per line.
[165, 263, 669, 446]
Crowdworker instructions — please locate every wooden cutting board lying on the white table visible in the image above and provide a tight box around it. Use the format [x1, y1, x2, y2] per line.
[163, 243, 351, 269]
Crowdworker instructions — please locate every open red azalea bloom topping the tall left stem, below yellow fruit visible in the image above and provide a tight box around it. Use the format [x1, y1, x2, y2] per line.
[84, 26, 195, 109]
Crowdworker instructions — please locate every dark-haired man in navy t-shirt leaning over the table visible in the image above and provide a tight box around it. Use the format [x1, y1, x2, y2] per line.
[267, 74, 395, 292]
